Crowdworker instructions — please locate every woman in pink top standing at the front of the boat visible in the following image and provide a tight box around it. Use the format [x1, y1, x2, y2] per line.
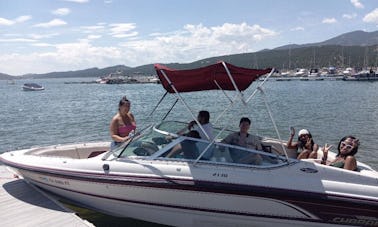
[110, 96, 136, 149]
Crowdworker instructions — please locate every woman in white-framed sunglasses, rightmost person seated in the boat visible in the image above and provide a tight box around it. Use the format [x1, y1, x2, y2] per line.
[321, 136, 360, 170]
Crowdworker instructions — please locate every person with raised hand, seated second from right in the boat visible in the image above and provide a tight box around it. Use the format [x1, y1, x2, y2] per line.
[287, 127, 319, 159]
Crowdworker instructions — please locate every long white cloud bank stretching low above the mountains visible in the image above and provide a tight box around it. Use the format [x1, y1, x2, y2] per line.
[0, 23, 278, 75]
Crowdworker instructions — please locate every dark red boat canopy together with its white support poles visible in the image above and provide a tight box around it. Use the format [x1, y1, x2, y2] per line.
[150, 61, 289, 160]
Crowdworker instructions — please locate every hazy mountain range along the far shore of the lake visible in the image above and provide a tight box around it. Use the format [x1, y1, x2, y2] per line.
[0, 31, 378, 80]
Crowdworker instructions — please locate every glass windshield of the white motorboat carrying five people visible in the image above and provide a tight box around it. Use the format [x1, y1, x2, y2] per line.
[114, 121, 287, 168]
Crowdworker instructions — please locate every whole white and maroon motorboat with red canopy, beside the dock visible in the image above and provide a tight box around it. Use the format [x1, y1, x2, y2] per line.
[0, 62, 378, 226]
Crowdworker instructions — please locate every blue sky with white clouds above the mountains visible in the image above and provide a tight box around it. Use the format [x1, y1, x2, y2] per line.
[0, 0, 378, 76]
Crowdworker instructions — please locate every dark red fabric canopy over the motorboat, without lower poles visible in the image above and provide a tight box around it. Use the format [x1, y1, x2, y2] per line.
[154, 62, 271, 93]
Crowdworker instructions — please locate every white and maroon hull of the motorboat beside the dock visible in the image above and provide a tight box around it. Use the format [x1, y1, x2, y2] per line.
[0, 141, 378, 226]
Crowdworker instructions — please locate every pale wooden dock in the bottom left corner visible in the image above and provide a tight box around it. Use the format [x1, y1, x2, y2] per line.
[0, 164, 94, 227]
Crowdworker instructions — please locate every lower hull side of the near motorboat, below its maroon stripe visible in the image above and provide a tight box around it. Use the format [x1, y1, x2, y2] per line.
[8, 167, 346, 226]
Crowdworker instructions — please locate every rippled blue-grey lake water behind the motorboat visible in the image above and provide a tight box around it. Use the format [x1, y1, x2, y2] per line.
[0, 78, 378, 225]
